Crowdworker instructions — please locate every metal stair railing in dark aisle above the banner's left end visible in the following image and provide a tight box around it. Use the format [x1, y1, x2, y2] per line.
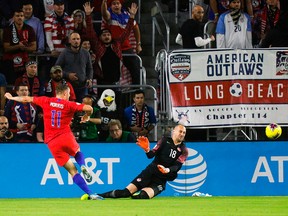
[151, 1, 170, 56]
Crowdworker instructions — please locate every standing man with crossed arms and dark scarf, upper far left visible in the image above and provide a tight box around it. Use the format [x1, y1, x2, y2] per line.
[3, 9, 37, 85]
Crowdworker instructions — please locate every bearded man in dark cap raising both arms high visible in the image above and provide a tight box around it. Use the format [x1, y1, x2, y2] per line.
[85, 1, 137, 95]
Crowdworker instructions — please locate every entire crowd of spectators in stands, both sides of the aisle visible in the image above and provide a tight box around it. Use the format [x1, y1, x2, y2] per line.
[0, 0, 288, 142]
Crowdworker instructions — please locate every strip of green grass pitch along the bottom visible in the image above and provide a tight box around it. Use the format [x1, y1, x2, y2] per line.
[0, 196, 288, 216]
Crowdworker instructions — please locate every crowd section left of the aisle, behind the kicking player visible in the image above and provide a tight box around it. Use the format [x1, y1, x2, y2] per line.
[0, 0, 156, 142]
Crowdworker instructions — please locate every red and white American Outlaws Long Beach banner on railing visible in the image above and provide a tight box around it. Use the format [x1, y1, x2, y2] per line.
[168, 49, 288, 128]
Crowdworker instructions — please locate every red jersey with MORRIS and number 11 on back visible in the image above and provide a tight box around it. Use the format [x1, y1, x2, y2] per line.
[33, 96, 84, 143]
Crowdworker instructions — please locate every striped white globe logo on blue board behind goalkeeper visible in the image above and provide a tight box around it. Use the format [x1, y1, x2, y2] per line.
[168, 148, 208, 194]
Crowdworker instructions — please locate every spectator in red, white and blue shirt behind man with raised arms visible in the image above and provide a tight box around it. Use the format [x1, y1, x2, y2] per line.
[101, 0, 142, 84]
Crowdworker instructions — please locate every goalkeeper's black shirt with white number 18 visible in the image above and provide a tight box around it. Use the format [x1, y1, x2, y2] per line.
[146, 137, 188, 172]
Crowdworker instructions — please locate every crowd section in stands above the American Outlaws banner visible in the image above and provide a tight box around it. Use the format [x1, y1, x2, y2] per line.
[176, 0, 288, 49]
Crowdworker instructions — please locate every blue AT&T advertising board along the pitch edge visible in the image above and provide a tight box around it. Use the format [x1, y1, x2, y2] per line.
[0, 141, 288, 198]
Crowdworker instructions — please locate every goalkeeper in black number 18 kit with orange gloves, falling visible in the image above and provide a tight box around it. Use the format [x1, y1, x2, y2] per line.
[99, 125, 188, 199]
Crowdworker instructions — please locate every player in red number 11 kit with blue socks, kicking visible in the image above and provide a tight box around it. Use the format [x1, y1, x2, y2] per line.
[5, 85, 103, 200]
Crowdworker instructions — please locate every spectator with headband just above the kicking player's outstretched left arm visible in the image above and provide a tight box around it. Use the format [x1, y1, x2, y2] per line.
[14, 60, 44, 96]
